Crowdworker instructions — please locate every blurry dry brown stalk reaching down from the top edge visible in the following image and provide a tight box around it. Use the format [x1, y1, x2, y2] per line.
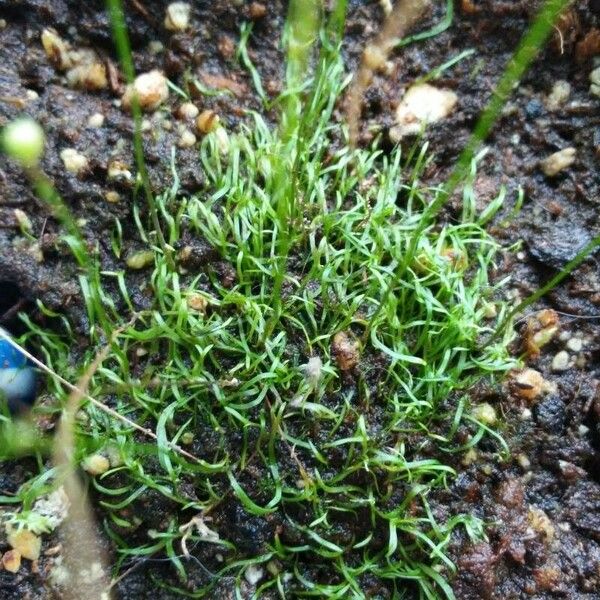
[346, 0, 430, 147]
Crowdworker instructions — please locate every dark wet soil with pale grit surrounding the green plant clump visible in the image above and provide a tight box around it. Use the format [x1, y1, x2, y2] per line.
[0, 0, 600, 600]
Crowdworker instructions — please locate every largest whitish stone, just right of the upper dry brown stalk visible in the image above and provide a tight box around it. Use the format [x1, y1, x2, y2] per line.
[390, 83, 458, 142]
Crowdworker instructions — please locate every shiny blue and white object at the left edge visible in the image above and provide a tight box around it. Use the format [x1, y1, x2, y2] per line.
[0, 327, 37, 413]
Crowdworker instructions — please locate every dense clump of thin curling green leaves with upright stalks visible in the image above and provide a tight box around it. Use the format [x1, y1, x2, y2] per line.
[3, 1, 584, 599]
